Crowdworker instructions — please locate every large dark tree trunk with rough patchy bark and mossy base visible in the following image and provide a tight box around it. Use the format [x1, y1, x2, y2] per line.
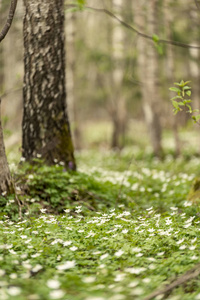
[22, 0, 76, 169]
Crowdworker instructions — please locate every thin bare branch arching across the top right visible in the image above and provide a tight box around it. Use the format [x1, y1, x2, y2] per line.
[66, 0, 200, 49]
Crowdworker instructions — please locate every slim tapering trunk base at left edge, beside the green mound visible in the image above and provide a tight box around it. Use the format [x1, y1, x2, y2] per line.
[0, 99, 14, 194]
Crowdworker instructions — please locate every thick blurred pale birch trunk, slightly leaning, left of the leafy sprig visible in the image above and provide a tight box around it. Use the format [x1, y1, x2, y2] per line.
[135, 0, 162, 157]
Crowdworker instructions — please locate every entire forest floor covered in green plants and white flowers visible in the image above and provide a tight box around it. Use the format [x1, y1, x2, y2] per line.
[0, 148, 200, 300]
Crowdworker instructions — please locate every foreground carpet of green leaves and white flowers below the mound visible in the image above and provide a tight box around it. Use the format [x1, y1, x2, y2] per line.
[0, 202, 200, 300]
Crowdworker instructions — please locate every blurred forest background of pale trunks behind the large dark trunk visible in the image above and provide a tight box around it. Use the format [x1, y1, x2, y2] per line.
[0, 0, 200, 156]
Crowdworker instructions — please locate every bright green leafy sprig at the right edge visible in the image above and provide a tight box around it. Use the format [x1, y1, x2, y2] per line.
[169, 80, 200, 125]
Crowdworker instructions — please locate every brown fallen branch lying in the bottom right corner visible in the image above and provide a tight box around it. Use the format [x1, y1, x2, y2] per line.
[143, 264, 200, 300]
